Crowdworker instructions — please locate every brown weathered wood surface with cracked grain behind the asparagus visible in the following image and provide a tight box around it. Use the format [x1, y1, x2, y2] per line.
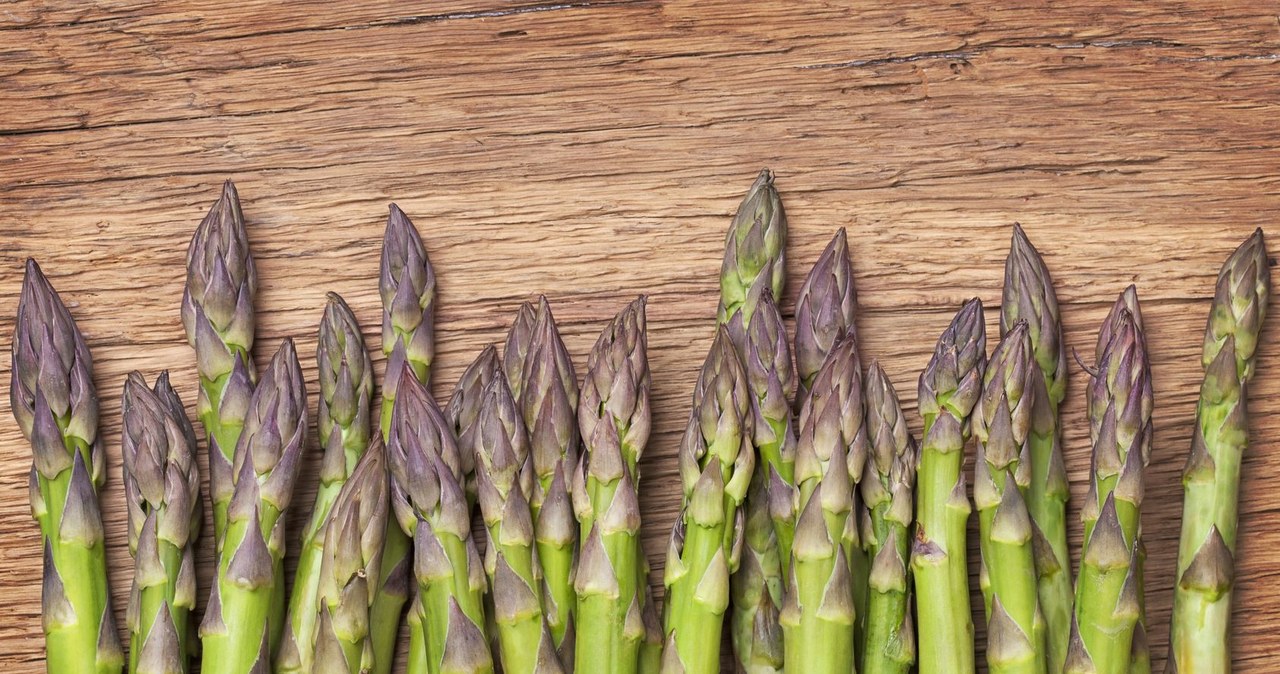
[0, 0, 1280, 674]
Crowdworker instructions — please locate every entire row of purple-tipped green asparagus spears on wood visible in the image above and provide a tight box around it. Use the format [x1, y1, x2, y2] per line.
[12, 171, 1270, 674]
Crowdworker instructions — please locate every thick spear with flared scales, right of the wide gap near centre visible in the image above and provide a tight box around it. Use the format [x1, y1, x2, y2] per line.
[662, 327, 755, 674]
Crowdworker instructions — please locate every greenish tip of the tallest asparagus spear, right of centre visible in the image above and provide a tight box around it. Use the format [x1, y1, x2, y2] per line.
[717, 169, 787, 324]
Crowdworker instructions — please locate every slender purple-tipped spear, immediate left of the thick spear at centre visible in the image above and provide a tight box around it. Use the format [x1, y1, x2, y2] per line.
[520, 297, 579, 661]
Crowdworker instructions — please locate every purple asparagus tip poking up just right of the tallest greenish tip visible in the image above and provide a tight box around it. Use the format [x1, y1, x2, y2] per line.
[795, 228, 858, 408]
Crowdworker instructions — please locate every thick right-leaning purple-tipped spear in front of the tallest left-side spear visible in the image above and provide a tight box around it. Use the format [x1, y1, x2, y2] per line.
[200, 339, 307, 674]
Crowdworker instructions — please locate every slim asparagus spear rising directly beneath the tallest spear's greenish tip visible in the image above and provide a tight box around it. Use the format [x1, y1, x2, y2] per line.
[727, 281, 795, 674]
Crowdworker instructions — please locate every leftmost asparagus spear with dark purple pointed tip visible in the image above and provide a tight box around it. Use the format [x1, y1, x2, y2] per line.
[9, 258, 124, 674]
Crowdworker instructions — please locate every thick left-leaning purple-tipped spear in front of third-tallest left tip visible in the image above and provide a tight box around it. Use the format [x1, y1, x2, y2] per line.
[386, 371, 493, 674]
